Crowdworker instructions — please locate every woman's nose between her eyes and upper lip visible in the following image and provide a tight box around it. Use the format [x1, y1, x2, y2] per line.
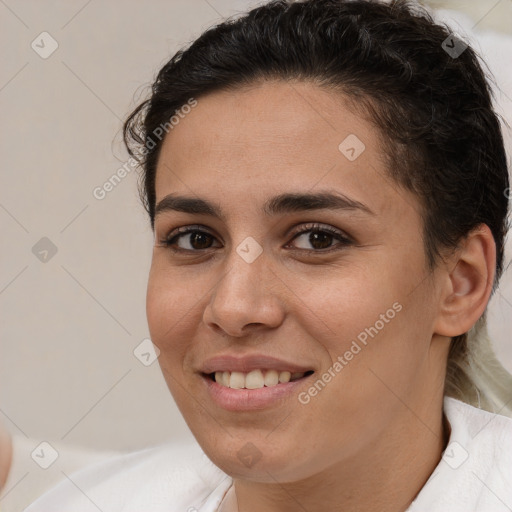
[203, 248, 285, 337]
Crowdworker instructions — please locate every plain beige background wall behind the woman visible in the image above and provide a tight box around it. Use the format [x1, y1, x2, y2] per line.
[0, 0, 512, 510]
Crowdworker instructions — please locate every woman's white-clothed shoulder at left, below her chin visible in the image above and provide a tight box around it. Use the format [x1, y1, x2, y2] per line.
[25, 444, 231, 512]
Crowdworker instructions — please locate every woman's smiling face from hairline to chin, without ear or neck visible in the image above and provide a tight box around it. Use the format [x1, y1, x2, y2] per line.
[147, 82, 445, 482]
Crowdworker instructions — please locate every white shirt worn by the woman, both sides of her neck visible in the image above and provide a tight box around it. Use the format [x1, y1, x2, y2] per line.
[25, 398, 512, 512]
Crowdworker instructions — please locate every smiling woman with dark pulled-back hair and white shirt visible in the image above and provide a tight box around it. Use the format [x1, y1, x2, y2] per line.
[24, 0, 512, 512]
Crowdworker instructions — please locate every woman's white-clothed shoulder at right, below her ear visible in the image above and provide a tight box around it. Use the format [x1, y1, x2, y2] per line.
[408, 397, 512, 512]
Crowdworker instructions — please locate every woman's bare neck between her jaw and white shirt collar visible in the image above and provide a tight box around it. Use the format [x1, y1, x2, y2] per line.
[221, 397, 448, 512]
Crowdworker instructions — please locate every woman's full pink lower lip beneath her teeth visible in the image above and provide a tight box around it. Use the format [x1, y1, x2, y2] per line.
[201, 373, 314, 412]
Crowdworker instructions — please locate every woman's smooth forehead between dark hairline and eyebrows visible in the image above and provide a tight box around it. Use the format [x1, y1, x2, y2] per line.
[156, 82, 414, 219]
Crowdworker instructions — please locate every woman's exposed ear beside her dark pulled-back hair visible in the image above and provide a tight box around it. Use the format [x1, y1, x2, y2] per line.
[434, 224, 496, 336]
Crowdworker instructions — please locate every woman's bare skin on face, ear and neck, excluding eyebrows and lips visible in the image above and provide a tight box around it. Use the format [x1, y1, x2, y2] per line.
[147, 81, 495, 512]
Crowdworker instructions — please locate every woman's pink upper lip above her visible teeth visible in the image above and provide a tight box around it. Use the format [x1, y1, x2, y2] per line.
[200, 354, 313, 374]
